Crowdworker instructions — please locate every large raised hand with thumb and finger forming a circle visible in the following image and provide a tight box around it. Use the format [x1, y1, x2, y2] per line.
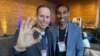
[15, 17, 41, 50]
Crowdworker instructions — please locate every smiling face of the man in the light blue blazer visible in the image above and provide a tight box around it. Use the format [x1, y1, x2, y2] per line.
[56, 6, 69, 24]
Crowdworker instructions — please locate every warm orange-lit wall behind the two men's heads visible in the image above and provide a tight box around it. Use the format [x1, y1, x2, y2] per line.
[0, 0, 100, 36]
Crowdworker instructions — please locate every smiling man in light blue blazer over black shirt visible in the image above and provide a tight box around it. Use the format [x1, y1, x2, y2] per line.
[51, 5, 83, 56]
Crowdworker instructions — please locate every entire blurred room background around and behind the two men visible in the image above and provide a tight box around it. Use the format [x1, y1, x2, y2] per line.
[0, 0, 100, 56]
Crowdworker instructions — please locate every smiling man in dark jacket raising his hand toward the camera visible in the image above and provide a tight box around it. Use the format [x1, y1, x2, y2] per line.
[10, 5, 53, 56]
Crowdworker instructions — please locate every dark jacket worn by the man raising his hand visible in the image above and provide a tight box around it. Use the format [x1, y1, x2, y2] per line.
[10, 29, 54, 56]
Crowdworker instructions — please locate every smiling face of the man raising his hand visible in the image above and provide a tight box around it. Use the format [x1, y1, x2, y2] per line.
[37, 7, 51, 29]
